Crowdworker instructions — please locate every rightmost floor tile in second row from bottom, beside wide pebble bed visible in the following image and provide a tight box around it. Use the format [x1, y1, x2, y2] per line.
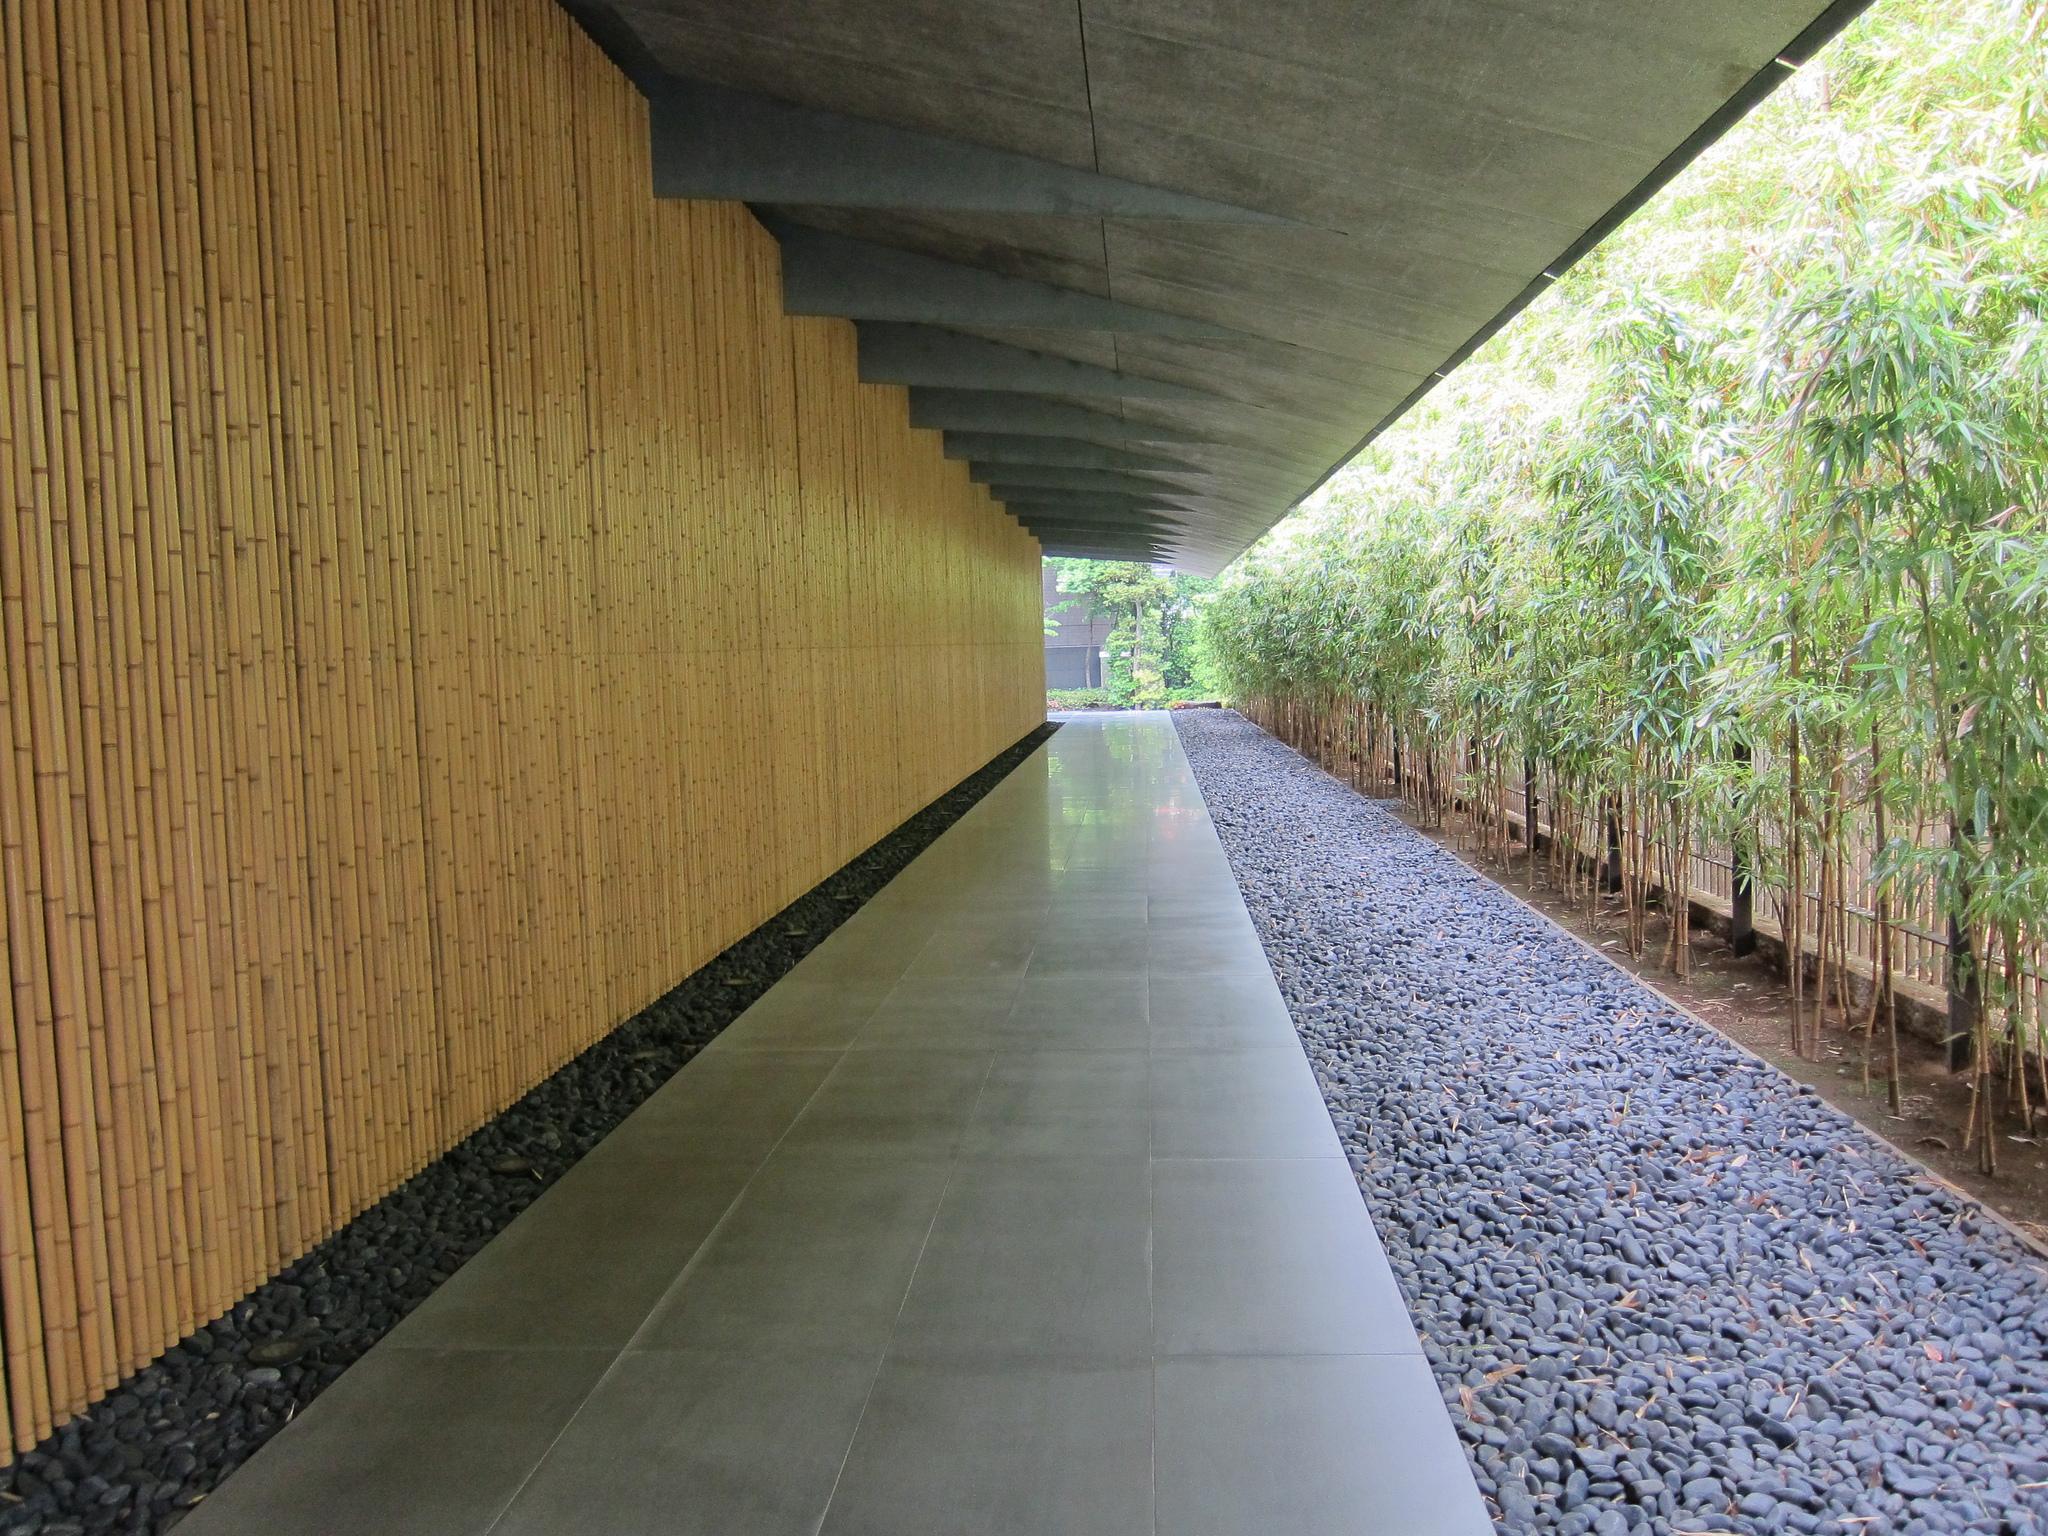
[1153, 1157, 1421, 1354]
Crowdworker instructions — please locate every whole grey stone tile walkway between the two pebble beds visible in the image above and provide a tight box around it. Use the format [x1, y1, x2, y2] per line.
[182, 715, 1491, 1536]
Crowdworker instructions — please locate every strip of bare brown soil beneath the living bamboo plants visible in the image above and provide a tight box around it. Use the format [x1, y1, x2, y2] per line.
[1401, 823, 2048, 1251]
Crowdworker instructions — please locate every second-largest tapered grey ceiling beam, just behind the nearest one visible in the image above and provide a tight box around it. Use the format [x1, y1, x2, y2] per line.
[766, 219, 1241, 340]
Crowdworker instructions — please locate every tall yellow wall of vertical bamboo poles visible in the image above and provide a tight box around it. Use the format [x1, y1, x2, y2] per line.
[0, 0, 1042, 1448]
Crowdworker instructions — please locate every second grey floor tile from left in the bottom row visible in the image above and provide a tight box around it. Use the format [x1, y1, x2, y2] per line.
[492, 1350, 881, 1536]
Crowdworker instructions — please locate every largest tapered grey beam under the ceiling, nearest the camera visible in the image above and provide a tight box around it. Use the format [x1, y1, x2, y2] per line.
[647, 78, 1290, 223]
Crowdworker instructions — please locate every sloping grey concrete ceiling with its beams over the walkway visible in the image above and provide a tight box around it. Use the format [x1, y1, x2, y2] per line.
[565, 0, 1866, 573]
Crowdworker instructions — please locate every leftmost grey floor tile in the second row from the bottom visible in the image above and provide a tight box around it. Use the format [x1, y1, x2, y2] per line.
[389, 1159, 756, 1350]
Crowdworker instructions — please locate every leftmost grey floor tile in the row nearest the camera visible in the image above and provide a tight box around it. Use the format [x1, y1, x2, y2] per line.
[178, 1350, 612, 1536]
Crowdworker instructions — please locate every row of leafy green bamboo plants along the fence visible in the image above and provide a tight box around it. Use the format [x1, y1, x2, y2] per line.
[1204, 0, 2048, 1169]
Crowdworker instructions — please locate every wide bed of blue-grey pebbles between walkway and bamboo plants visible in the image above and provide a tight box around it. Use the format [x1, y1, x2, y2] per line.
[1174, 713, 2048, 1536]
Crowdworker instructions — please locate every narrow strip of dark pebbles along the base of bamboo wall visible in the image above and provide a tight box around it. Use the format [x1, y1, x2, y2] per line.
[0, 725, 1057, 1536]
